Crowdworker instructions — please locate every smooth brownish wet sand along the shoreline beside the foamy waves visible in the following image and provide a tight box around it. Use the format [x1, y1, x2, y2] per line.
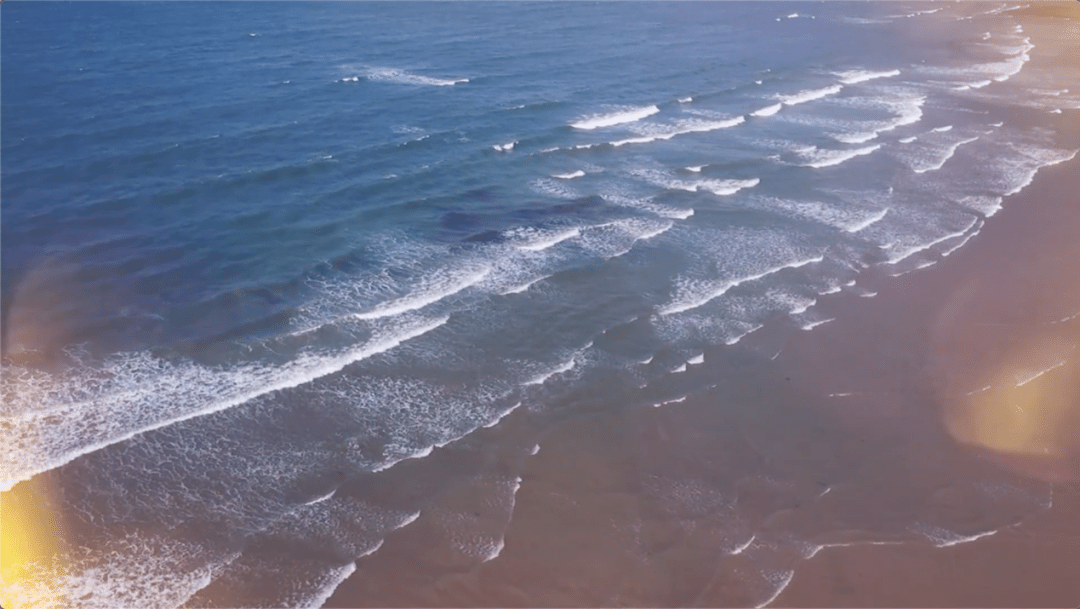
[326, 2, 1080, 607]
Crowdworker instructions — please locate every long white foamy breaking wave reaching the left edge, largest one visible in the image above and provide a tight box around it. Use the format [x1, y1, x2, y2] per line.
[0, 316, 449, 491]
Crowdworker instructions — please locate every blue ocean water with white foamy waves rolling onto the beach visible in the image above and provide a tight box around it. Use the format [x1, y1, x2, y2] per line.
[0, 2, 1080, 607]
